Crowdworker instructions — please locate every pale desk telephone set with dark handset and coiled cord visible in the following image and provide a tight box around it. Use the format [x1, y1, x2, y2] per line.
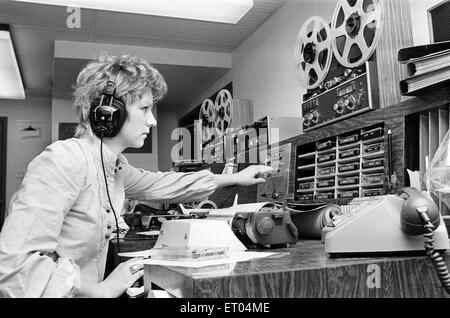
[323, 188, 450, 294]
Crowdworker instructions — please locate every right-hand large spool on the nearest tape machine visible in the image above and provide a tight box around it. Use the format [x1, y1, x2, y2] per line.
[331, 0, 383, 68]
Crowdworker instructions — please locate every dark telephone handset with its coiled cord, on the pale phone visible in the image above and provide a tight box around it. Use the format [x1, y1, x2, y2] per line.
[398, 188, 450, 295]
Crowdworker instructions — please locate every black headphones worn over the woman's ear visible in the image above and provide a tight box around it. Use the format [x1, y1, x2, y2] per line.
[89, 81, 127, 137]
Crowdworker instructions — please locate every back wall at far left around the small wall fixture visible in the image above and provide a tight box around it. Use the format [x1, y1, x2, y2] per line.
[0, 97, 51, 208]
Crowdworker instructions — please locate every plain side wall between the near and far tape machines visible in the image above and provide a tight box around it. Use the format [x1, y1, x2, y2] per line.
[185, 0, 337, 119]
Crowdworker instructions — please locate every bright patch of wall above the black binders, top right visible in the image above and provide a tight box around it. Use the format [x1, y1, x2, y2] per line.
[410, 0, 446, 45]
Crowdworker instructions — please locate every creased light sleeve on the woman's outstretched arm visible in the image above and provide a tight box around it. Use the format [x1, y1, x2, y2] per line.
[124, 164, 217, 203]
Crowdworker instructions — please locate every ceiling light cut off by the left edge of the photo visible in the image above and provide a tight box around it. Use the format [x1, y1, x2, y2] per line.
[0, 24, 25, 99]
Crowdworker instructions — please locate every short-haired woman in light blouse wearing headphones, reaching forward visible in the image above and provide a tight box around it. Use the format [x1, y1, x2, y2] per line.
[0, 56, 270, 297]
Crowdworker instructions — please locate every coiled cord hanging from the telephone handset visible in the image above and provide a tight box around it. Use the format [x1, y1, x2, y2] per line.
[417, 209, 450, 295]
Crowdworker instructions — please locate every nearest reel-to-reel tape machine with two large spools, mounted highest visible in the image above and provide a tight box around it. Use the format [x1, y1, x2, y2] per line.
[295, 0, 384, 131]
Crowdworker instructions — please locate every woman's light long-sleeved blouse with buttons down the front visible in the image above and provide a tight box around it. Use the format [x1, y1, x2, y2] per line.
[0, 136, 217, 297]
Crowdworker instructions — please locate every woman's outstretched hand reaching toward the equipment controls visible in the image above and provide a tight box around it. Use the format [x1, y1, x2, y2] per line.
[216, 165, 274, 187]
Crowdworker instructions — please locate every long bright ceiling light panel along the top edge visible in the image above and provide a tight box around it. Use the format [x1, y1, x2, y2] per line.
[11, 0, 253, 23]
